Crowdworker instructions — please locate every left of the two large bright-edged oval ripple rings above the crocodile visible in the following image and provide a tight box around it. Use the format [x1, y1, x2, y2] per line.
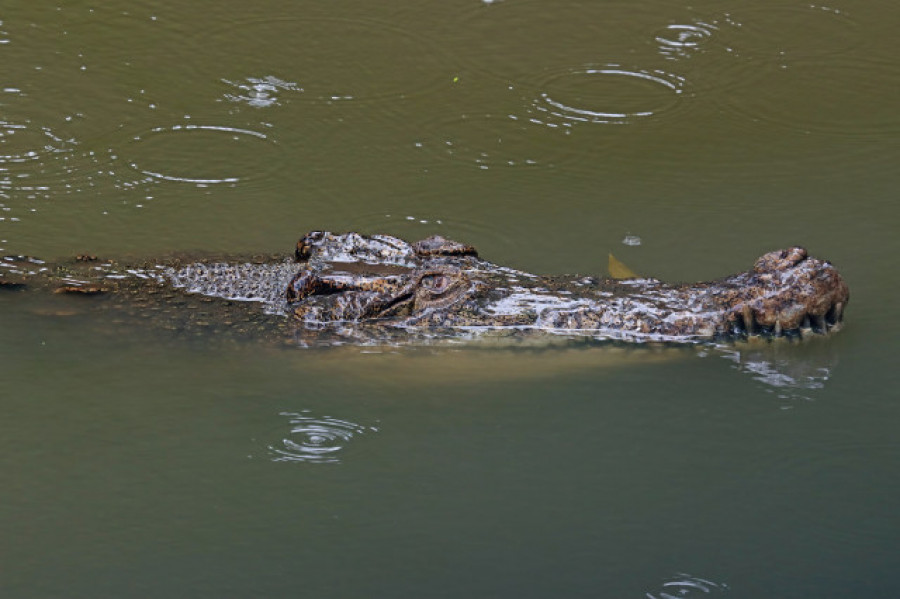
[125, 124, 282, 186]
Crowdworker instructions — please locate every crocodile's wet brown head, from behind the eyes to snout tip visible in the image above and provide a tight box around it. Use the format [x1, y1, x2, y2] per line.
[286, 232, 849, 341]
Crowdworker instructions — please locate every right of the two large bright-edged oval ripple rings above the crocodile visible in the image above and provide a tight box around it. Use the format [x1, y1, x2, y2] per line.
[528, 64, 687, 128]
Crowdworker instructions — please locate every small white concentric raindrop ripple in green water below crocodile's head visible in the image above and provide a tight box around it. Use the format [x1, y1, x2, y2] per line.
[269, 410, 378, 464]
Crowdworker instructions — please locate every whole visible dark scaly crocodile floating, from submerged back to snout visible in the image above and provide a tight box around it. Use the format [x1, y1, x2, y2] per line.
[0, 231, 849, 345]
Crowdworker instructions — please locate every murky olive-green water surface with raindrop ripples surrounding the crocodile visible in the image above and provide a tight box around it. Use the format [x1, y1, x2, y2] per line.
[0, 0, 900, 598]
